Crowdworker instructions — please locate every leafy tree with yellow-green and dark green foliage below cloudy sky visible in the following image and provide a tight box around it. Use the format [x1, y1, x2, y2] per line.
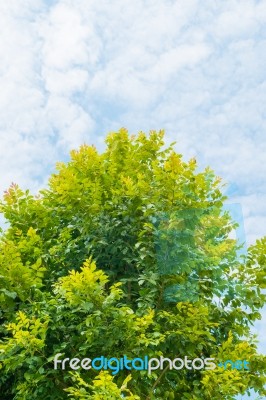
[0, 129, 266, 400]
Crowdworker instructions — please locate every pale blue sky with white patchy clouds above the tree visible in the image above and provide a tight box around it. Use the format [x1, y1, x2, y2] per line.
[0, 0, 266, 396]
